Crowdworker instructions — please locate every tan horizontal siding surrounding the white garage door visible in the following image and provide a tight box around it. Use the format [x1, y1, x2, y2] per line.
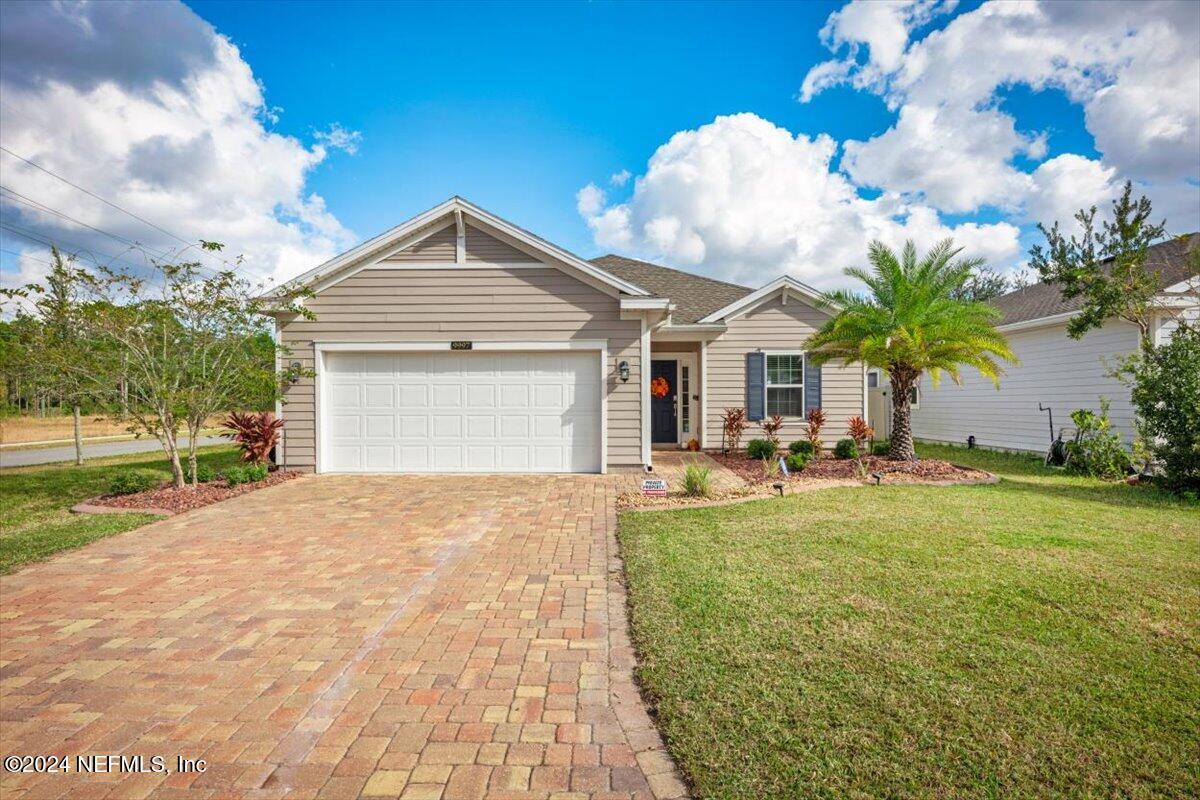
[280, 266, 641, 469]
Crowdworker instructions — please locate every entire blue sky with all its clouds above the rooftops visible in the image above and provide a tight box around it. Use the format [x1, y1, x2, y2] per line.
[0, 0, 1200, 285]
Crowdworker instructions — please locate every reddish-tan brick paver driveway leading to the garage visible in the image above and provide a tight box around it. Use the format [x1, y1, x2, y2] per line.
[0, 476, 684, 800]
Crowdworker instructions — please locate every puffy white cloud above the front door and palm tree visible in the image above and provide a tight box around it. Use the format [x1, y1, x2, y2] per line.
[577, 114, 1019, 287]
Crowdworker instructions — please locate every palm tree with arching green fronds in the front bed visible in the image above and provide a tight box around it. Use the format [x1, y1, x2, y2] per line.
[806, 239, 1016, 461]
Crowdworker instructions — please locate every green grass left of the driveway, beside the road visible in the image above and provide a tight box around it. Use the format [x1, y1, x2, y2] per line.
[0, 445, 238, 575]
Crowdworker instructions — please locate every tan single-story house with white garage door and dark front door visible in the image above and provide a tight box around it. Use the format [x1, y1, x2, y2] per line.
[265, 197, 865, 473]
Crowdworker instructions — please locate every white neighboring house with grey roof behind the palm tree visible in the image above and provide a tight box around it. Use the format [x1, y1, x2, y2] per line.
[902, 234, 1200, 452]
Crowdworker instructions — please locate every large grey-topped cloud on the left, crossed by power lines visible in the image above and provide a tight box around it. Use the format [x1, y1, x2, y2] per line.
[0, 2, 360, 287]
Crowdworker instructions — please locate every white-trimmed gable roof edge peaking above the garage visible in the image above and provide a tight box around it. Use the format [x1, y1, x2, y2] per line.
[277, 197, 650, 297]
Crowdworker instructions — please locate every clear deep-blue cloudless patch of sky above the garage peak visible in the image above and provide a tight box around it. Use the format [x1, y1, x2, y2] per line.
[190, 1, 893, 255]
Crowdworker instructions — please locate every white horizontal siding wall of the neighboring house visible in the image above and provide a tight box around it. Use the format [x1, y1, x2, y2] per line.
[912, 321, 1138, 452]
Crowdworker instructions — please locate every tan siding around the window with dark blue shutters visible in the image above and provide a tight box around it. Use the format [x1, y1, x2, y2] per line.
[706, 297, 863, 447]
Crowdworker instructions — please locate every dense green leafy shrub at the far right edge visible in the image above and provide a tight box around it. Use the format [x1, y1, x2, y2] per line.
[1130, 321, 1200, 493]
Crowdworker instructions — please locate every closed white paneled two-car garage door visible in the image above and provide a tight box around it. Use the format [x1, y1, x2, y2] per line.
[320, 350, 601, 473]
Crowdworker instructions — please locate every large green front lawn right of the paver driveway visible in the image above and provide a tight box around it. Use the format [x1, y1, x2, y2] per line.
[620, 446, 1200, 799]
